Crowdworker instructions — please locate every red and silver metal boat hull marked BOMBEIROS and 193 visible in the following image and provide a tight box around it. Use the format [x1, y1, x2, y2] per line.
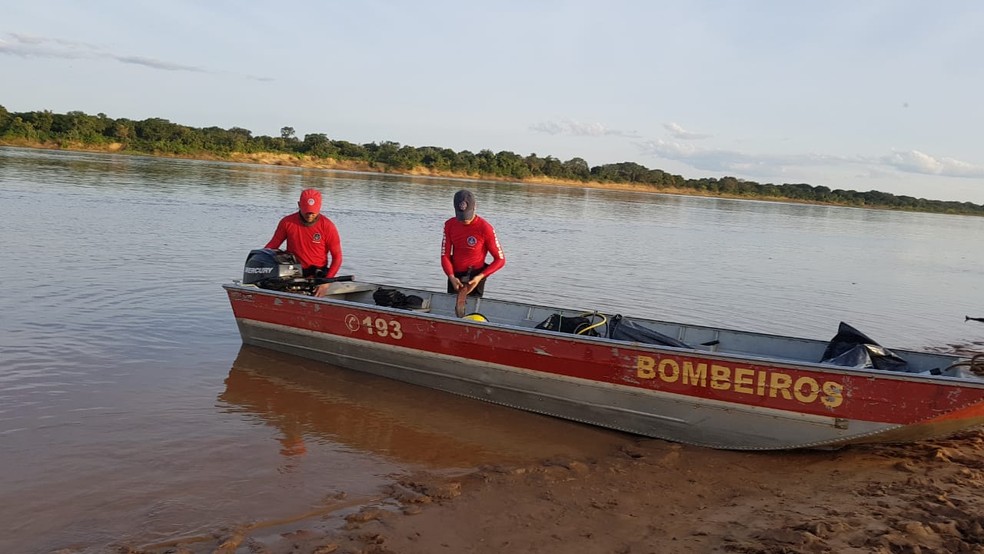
[226, 286, 984, 450]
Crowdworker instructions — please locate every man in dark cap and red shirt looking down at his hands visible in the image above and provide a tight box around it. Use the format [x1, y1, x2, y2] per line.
[441, 190, 506, 296]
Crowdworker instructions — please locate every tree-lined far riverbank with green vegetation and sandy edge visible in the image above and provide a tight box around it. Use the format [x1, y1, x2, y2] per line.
[0, 106, 984, 215]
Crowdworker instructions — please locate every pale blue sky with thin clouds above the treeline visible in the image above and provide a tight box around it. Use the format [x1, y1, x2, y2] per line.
[0, 0, 984, 204]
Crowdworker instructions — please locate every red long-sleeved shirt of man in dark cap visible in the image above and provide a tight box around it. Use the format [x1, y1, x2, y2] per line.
[441, 215, 506, 277]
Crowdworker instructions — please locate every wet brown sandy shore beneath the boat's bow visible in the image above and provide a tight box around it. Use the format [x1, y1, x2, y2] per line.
[115, 424, 984, 554]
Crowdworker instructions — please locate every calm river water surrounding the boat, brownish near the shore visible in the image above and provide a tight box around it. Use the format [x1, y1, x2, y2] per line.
[0, 144, 984, 552]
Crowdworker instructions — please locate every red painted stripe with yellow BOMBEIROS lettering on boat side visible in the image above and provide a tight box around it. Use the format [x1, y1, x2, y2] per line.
[228, 289, 984, 425]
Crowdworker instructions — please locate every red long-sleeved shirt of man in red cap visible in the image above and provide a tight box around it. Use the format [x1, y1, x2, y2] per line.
[266, 212, 342, 277]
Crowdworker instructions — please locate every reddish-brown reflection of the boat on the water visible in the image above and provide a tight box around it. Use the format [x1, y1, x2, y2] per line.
[219, 346, 618, 469]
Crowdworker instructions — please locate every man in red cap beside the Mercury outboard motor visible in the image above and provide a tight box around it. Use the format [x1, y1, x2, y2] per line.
[266, 189, 342, 296]
